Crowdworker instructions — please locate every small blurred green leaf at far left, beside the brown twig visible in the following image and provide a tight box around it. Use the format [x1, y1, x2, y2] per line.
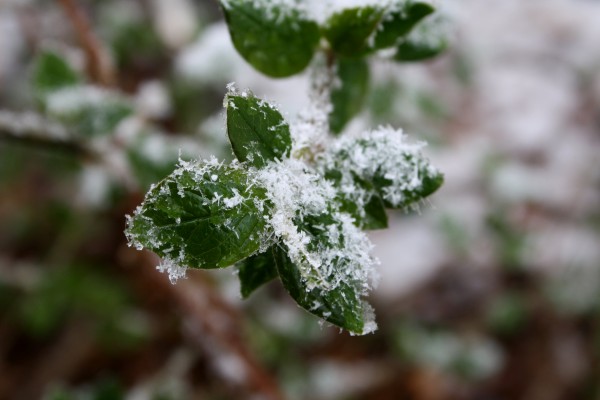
[33, 51, 81, 96]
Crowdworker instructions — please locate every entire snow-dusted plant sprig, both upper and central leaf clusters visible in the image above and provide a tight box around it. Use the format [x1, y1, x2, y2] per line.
[126, 0, 445, 334]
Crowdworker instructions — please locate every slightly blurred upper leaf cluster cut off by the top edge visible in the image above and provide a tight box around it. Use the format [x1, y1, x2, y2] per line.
[221, 0, 447, 134]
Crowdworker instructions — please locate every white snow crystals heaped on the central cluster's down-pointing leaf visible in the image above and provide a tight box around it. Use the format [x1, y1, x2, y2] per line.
[256, 159, 378, 333]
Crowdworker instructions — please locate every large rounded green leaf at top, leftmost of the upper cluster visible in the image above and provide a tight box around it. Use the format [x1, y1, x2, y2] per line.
[221, 0, 320, 78]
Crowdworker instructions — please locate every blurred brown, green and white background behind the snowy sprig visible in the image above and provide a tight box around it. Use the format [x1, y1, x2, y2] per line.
[0, 0, 600, 400]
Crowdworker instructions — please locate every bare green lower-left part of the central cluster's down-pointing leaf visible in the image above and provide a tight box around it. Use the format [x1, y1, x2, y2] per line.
[275, 249, 366, 334]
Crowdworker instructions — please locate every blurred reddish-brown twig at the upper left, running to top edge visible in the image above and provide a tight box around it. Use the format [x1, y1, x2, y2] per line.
[58, 0, 115, 86]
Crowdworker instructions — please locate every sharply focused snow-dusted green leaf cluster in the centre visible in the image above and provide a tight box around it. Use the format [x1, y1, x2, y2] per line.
[126, 91, 442, 334]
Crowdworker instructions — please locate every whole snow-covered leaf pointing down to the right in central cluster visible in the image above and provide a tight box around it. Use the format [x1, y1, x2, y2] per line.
[258, 159, 377, 333]
